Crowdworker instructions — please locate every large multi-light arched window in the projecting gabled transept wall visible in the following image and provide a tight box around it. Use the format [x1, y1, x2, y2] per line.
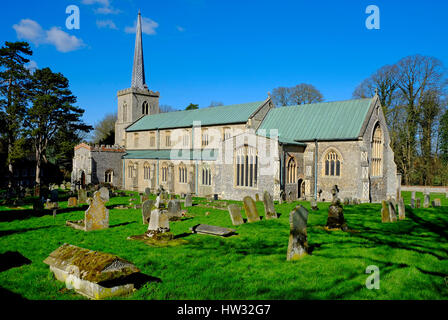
[235, 146, 258, 187]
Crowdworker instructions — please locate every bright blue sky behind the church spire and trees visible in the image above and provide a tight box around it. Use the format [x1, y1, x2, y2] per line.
[0, 0, 448, 124]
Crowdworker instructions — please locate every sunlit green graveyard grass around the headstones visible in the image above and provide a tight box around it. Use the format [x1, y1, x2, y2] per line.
[0, 192, 448, 300]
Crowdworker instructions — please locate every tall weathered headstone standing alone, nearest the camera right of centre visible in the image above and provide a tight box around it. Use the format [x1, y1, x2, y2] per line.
[286, 205, 308, 260]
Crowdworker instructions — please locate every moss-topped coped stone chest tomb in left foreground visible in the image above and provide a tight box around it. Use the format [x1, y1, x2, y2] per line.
[43, 243, 140, 299]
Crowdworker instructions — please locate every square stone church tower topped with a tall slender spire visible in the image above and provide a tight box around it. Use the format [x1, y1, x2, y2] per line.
[115, 11, 160, 146]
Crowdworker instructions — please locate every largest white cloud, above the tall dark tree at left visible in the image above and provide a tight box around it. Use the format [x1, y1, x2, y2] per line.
[12, 19, 84, 52]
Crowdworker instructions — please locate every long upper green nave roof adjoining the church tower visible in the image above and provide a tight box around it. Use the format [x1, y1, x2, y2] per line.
[126, 101, 265, 131]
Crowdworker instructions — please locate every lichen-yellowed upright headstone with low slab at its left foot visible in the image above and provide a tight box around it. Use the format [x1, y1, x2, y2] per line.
[66, 191, 109, 231]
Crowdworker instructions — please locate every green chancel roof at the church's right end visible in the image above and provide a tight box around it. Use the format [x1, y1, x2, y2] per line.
[257, 98, 372, 142]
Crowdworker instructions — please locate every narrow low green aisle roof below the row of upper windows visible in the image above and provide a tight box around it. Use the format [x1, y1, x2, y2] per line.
[123, 149, 218, 161]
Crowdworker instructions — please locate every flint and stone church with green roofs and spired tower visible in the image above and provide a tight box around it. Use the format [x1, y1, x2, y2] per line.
[72, 14, 399, 202]
